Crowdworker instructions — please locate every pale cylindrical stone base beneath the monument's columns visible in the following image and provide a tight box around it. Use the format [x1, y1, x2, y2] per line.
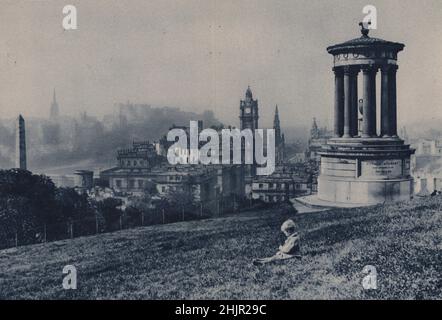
[317, 138, 414, 206]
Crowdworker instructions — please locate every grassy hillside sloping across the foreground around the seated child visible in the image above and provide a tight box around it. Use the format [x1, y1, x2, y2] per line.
[0, 197, 442, 299]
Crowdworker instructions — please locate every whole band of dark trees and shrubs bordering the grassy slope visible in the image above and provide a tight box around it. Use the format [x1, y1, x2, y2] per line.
[0, 169, 284, 249]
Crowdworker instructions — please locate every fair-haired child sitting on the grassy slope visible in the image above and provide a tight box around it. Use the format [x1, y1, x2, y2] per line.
[253, 219, 301, 265]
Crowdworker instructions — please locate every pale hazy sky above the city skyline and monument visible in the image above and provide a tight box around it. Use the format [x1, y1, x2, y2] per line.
[0, 0, 442, 126]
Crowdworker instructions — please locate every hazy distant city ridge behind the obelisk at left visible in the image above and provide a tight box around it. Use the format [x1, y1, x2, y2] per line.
[0, 103, 220, 171]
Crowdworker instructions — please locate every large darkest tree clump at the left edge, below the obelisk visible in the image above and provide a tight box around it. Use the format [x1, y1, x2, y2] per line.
[0, 169, 95, 247]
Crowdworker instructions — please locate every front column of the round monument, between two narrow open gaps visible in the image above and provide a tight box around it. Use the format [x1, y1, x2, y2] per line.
[362, 65, 373, 138]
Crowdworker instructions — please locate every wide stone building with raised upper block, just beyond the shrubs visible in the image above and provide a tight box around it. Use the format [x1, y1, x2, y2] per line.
[100, 142, 244, 212]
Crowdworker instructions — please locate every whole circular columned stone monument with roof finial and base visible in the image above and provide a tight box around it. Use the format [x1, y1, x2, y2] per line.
[317, 24, 414, 206]
